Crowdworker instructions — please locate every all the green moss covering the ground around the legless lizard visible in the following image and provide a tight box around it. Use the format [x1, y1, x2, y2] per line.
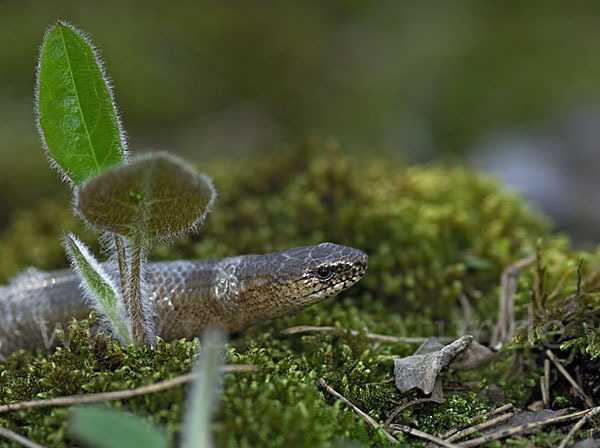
[0, 140, 597, 447]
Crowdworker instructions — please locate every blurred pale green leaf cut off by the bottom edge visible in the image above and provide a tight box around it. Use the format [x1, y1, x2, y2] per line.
[70, 406, 169, 448]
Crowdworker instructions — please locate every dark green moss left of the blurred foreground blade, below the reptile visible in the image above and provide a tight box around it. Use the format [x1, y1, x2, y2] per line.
[0, 320, 198, 447]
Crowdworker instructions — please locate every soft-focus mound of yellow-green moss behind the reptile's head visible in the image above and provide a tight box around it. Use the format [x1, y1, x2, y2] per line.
[172, 139, 549, 332]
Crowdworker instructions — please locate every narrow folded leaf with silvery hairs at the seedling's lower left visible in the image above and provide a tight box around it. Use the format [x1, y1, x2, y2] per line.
[65, 232, 132, 344]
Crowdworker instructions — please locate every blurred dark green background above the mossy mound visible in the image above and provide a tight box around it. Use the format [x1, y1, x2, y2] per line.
[0, 0, 600, 240]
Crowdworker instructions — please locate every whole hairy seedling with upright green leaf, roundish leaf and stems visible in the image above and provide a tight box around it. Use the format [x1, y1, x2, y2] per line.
[36, 21, 216, 346]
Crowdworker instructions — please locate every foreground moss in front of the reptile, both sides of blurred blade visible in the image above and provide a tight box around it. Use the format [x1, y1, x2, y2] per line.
[0, 308, 488, 447]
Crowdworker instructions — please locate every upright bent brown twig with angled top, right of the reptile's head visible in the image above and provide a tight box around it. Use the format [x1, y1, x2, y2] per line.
[490, 255, 536, 348]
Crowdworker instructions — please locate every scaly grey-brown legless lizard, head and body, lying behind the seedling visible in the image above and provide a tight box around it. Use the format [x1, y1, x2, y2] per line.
[0, 243, 368, 359]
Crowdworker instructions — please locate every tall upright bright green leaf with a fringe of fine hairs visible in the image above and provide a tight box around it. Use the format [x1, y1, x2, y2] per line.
[36, 22, 125, 184]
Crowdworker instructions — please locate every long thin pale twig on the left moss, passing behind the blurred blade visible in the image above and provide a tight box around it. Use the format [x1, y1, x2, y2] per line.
[0, 364, 258, 413]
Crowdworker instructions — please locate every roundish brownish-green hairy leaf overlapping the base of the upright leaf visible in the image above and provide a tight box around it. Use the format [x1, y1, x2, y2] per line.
[75, 154, 215, 239]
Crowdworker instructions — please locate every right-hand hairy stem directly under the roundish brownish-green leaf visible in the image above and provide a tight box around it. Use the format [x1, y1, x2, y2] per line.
[126, 231, 154, 347]
